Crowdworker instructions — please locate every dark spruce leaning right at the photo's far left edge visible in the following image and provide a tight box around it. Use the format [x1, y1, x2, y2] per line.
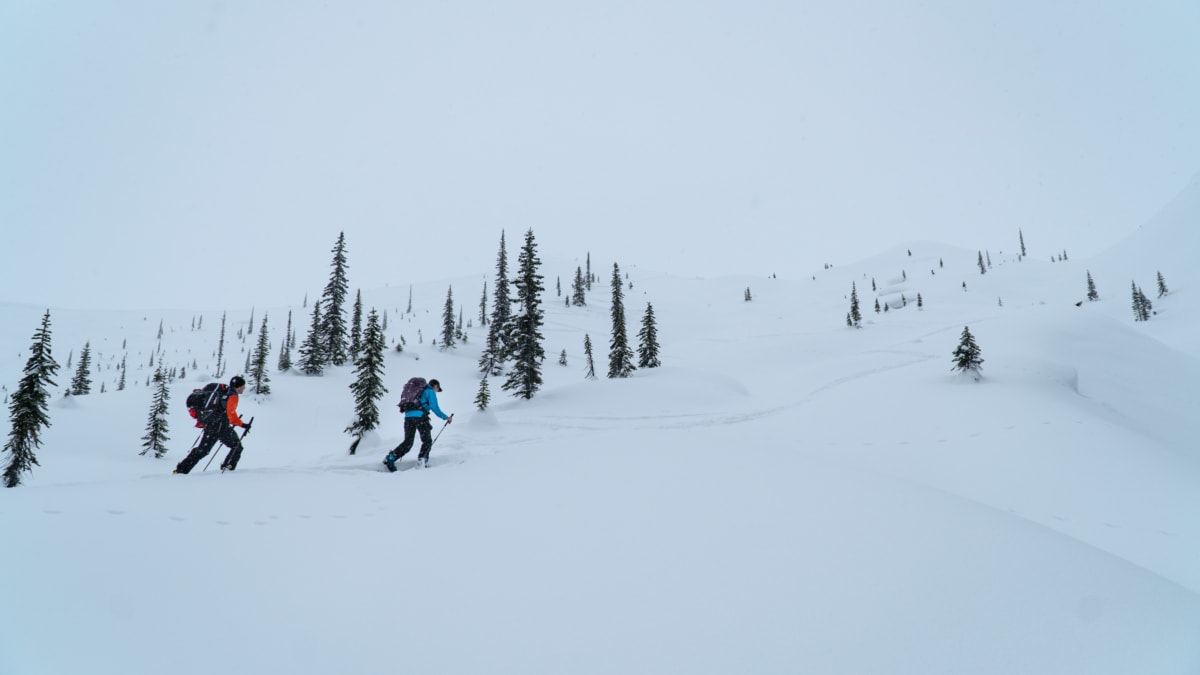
[4, 310, 59, 488]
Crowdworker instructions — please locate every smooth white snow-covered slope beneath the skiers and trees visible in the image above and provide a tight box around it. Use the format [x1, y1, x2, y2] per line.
[0, 176, 1200, 675]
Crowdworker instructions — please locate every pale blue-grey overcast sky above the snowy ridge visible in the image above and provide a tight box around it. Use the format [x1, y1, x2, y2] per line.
[0, 0, 1200, 307]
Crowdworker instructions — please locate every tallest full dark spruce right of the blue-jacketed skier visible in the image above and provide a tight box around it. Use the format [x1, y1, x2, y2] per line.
[502, 229, 546, 399]
